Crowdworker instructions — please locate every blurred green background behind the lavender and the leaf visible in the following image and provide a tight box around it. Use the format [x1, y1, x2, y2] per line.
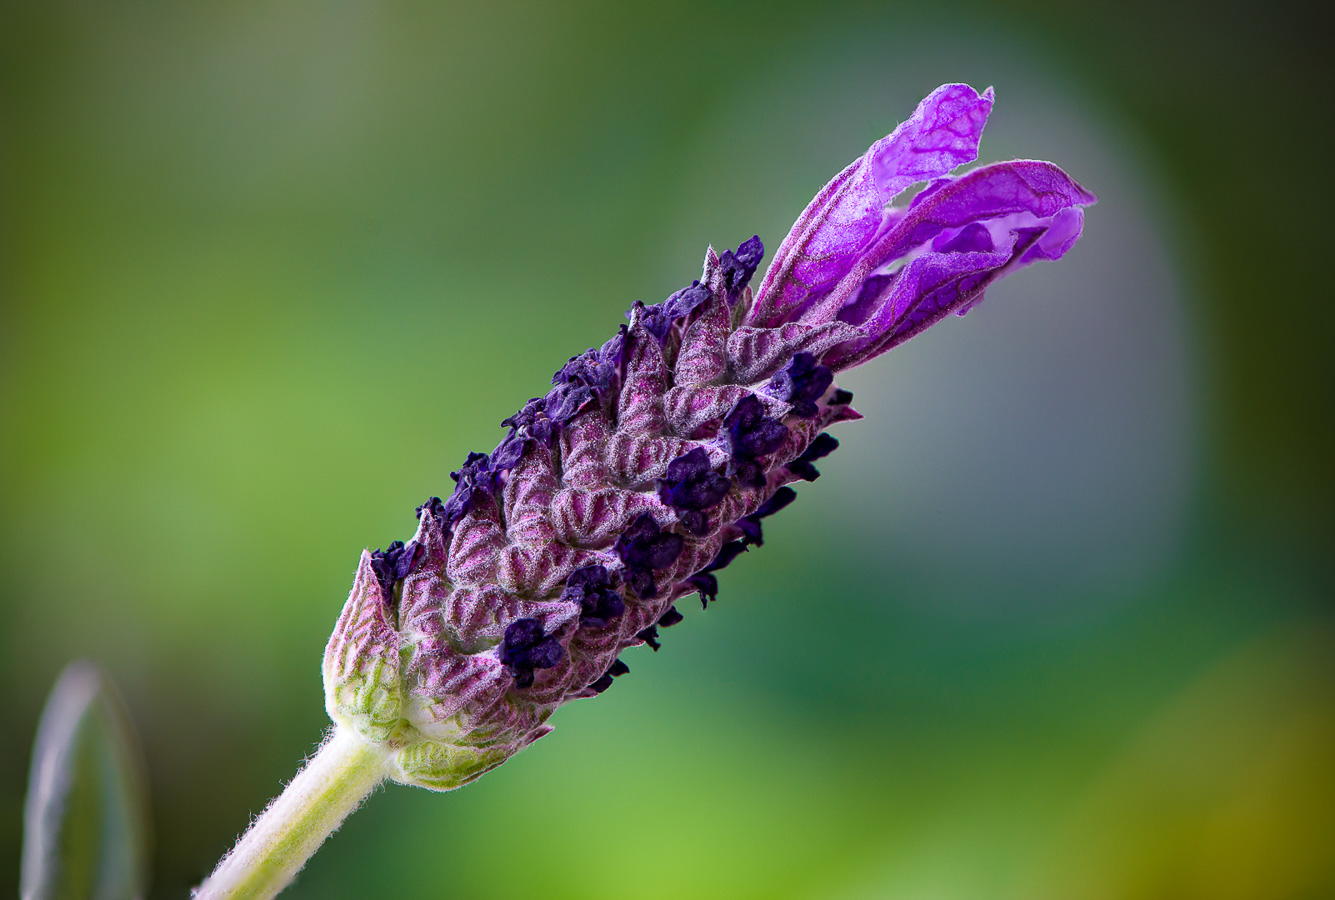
[0, 0, 1335, 900]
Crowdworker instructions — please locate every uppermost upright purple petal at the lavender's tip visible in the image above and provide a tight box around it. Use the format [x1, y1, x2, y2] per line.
[748, 84, 992, 327]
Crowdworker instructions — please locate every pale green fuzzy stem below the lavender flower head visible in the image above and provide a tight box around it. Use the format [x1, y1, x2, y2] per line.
[195, 728, 388, 900]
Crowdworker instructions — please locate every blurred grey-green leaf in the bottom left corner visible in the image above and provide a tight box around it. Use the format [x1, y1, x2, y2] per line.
[20, 661, 150, 900]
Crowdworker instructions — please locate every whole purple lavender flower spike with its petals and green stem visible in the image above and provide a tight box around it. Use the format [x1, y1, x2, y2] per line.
[198, 84, 1095, 897]
